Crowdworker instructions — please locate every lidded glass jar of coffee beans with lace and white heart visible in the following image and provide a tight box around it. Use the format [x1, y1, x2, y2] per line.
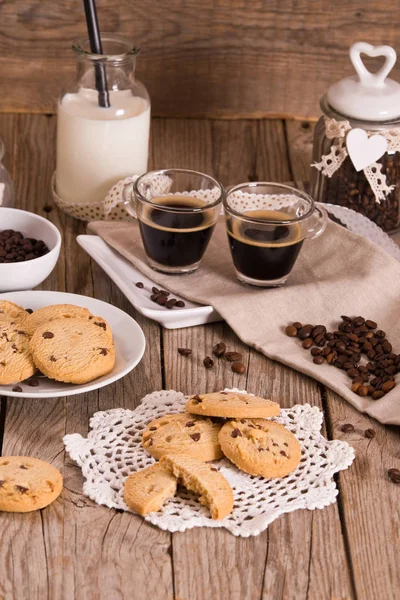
[311, 42, 400, 231]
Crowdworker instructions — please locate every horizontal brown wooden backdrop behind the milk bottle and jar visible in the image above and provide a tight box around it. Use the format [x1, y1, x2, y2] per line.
[0, 0, 400, 117]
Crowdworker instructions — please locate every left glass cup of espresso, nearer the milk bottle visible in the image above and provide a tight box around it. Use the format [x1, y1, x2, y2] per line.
[127, 169, 225, 274]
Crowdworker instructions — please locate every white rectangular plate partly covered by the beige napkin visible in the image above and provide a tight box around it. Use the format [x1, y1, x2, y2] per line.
[76, 235, 221, 329]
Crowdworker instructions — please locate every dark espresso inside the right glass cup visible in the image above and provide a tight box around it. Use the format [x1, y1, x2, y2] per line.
[228, 210, 305, 281]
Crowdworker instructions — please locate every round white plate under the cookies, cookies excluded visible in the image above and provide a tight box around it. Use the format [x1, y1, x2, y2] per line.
[0, 291, 146, 398]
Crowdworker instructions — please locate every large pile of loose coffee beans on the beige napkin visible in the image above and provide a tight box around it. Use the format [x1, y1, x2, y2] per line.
[285, 315, 400, 400]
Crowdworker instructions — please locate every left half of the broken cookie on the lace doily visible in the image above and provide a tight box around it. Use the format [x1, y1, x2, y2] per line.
[124, 463, 177, 515]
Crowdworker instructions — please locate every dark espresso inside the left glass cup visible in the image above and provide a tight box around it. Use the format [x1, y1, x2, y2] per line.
[138, 195, 215, 267]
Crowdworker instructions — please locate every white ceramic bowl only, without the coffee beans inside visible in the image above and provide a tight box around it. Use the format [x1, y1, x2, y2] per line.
[0, 208, 61, 292]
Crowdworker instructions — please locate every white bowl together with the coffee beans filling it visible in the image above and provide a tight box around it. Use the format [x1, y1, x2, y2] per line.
[0, 208, 61, 292]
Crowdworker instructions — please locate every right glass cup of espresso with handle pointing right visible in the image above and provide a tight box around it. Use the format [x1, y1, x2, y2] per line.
[224, 182, 327, 287]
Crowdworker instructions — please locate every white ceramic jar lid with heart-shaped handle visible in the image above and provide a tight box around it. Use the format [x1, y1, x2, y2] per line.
[327, 42, 400, 121]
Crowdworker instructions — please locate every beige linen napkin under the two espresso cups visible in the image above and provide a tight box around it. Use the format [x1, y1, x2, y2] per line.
[88, 221, 400, 425]
